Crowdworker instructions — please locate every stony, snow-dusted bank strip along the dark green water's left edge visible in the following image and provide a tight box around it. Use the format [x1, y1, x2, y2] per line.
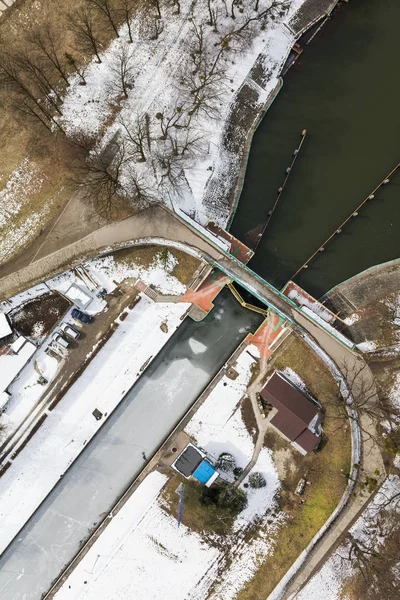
[203, 0, 339, 227]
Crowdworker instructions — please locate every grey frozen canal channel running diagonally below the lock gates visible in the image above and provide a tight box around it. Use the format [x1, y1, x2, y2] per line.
[0, 292, 261, 600]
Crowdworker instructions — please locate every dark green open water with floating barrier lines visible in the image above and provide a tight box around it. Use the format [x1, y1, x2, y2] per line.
[231, 0, 400, 296]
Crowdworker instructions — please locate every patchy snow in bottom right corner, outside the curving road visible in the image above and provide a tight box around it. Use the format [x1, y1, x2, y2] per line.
[293, 475, 400, 600]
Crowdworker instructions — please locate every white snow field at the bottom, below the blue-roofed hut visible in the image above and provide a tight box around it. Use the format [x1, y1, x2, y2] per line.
[55, 472, 219, 600]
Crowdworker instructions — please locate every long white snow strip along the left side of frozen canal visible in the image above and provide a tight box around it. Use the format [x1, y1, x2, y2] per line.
[0, 297, 189, 552]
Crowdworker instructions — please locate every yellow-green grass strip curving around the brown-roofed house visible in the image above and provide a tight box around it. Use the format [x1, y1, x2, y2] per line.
[238, 336, 351, 600]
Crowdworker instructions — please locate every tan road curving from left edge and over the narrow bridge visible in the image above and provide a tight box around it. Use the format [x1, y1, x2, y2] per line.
[0, 205, 354, 349]
